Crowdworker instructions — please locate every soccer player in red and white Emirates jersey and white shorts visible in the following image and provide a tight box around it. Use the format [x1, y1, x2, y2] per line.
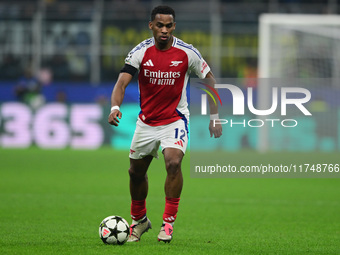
[108, 6, 222, 242]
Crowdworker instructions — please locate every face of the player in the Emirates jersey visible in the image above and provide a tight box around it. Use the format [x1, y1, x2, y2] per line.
[149, 14, 176, 48]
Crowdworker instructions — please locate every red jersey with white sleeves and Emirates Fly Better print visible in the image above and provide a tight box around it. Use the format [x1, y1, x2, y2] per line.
[125, 37, 210, 126]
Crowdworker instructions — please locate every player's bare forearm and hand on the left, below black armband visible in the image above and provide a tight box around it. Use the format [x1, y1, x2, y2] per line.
[108, 72, 133, 126]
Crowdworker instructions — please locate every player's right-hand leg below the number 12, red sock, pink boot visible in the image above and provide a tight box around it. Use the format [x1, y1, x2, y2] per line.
[158, 148, 184, 242]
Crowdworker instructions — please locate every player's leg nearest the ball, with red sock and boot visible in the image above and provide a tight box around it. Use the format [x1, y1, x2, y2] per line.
[128, 156, 153, 242]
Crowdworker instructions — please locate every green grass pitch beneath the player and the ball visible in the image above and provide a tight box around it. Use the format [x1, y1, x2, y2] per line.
[0, 148, 340, 255]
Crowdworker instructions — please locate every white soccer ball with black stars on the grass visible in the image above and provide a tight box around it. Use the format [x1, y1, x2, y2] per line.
[99, 216, 130, 244]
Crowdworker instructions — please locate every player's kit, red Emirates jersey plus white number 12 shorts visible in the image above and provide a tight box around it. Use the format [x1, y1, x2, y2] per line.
[125, 37, 210, 159]
